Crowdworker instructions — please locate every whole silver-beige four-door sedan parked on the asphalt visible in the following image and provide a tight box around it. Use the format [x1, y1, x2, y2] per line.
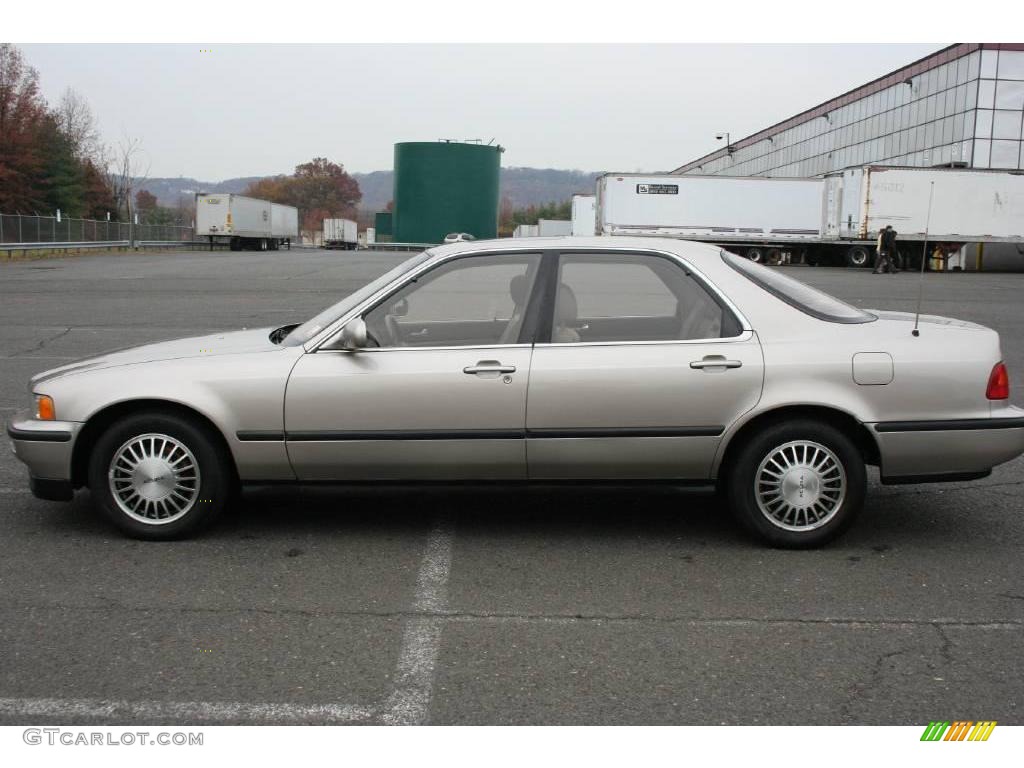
[7, 238, 1024, 547]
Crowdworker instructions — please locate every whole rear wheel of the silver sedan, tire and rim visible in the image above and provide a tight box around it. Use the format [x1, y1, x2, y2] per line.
[728, 420, 866, 549]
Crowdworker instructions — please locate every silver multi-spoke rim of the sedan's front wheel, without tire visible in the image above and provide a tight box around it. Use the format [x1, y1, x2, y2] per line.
[108, 434, 200, 525]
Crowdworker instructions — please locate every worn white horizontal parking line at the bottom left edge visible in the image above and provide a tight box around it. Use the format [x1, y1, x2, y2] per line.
[0, 698, 374, 723]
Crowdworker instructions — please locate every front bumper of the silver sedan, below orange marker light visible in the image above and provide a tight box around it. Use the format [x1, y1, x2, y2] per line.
[7, 413, 82, 501]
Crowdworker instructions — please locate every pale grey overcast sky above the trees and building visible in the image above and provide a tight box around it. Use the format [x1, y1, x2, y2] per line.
[23, 44, 942, 181]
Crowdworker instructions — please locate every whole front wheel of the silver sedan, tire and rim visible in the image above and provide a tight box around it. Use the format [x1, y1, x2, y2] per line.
[89, 414, 233, 540]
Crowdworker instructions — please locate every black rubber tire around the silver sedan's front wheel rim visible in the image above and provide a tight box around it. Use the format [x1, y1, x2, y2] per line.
[89, 413, 237, 541]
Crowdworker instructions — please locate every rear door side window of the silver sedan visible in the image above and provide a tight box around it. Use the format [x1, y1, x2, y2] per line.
[551, 254, 740, 344]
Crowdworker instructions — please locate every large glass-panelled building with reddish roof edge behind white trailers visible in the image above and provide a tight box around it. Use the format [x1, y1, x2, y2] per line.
[673, 43, 1024, 176]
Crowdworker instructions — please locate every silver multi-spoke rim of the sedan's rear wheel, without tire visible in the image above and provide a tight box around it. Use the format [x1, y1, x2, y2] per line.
[754, 440, 846, 530]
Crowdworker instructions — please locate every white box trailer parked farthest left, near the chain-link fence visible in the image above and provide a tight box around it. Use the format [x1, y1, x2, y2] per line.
[196, 193, 298, 251]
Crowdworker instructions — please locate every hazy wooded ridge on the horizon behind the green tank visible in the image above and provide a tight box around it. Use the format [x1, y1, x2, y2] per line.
[140, 168, 599, 211]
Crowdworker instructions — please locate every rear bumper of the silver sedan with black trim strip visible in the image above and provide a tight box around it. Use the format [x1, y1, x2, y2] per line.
[873, 408, 1024, 482]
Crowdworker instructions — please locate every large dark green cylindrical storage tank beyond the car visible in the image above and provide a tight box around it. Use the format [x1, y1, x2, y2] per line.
[393, 141, 502, 243]
